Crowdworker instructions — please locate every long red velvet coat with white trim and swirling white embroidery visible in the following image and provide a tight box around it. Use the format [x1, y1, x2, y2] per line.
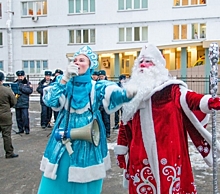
[115, 80, 220, 194]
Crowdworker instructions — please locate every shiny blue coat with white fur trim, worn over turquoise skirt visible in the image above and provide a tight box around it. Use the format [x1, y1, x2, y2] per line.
[40, 76, 130, 183]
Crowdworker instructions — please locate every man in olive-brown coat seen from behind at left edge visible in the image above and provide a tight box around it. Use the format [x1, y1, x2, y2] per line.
[0, 72, 18, 158]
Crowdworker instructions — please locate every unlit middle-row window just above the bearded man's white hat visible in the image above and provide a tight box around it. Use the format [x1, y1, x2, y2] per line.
[119, 26, 148, 42]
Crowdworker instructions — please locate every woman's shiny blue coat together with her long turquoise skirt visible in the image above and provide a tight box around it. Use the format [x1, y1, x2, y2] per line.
[38, 76, 130, 194]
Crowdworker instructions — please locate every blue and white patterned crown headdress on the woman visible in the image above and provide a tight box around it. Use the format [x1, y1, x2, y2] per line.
[73, 46, 99, 69]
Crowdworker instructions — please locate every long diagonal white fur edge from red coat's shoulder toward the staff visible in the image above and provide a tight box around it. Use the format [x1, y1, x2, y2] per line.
[180, 86, 220, 166]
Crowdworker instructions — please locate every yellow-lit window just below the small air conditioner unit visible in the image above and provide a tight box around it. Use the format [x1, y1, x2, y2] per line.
[23, 31, 48, 45]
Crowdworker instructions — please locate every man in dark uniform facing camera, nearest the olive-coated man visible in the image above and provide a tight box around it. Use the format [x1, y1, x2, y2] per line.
[15, 70, 33, 134]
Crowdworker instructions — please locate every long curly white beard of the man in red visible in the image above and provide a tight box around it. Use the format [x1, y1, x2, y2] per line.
[122, 66, 170, 124]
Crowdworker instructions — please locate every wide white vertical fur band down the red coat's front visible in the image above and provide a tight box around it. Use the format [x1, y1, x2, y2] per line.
[140, 99, 160, 194]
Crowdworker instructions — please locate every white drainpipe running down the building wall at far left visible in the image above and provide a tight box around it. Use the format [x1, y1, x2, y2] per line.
[6, 0, 15, 82]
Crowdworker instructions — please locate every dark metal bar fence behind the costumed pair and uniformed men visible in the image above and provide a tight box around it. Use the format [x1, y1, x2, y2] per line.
[27, 76, 216, 94]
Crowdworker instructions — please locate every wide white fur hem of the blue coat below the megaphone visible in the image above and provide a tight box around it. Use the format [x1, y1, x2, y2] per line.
[68, 163, 106, 183]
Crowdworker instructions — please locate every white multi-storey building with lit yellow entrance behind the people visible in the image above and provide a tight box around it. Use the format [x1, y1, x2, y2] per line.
[0, 0, 220, 77]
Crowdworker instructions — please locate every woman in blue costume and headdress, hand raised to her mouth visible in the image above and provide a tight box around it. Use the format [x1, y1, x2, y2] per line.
[38, 46, 136, 194]
